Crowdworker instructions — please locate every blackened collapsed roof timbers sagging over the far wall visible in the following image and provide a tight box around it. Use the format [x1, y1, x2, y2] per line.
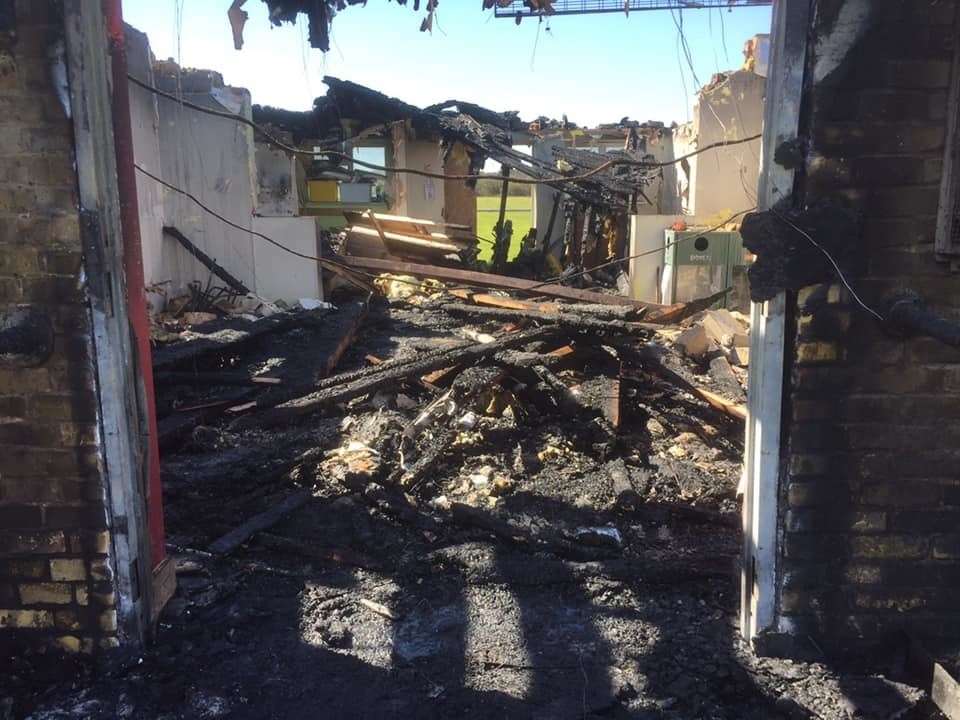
[253, 76, 659, 210]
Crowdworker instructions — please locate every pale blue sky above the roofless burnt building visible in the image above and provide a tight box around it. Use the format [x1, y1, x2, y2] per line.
[123, 0, 770, 125]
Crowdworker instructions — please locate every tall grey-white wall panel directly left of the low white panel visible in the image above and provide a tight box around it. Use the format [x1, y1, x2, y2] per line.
[158, 87, 262, 296]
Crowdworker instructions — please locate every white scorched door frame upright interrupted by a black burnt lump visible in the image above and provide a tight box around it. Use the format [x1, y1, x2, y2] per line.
[740, 0, 812, 640]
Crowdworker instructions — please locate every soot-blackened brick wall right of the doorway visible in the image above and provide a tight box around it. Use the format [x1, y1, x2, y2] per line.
[779, 0, 960, 643]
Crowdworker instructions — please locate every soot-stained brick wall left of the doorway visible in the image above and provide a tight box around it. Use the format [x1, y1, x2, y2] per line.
[0, 0, 117, 652]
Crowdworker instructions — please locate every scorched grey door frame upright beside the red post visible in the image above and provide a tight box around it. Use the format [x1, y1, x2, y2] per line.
[63, 0, 153, 645]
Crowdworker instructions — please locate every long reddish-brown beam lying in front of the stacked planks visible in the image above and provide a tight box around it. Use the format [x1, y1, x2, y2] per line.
[337, 255, 677, 314]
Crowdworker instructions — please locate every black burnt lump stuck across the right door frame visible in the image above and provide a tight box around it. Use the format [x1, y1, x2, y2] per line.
[740, 201, 863, 302]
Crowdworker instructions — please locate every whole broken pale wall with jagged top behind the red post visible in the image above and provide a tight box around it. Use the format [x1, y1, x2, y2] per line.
[126, 26, 323, 306]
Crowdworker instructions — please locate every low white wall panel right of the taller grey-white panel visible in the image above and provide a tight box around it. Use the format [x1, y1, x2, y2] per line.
[253, 217, 323, 303]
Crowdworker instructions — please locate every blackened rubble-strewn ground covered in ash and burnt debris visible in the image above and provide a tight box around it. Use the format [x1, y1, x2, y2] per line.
[8, 290, 935, 720]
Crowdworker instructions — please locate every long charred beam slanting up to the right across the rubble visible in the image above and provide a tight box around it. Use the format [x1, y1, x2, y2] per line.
[249, 327, 558, 427]
